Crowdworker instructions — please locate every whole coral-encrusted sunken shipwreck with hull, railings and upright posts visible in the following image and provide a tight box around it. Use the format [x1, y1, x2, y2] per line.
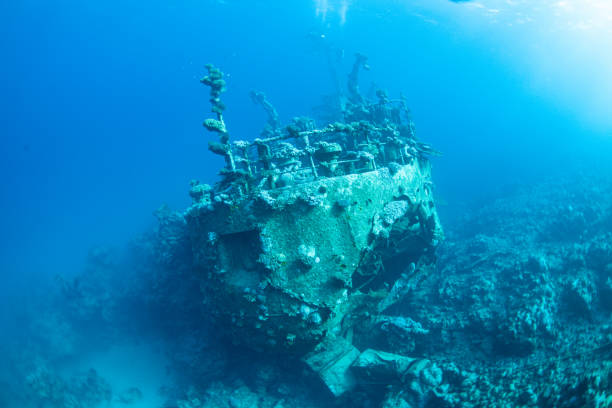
[185, 62, 442, 394]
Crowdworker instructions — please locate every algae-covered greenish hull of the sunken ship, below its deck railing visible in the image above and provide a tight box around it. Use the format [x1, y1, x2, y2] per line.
[186, 159, 441, 353]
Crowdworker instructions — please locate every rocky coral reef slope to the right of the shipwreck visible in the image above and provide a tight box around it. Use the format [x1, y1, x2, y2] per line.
[392, 177, 612, 407]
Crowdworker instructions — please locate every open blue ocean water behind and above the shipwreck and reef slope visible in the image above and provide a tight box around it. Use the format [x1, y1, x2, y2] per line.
[0, 0, 612, 407]
